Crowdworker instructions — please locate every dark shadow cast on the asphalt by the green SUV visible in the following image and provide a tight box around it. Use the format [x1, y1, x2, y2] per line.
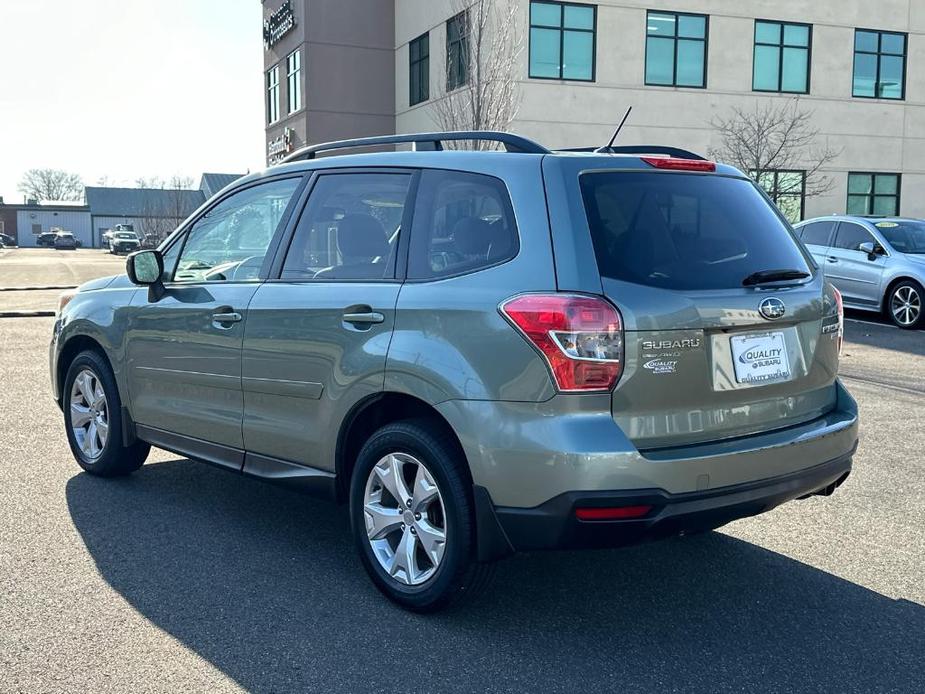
[67, 460, 925, 692]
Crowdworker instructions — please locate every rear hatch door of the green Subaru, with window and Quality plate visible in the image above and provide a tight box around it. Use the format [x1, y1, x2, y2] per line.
[553, 157, 838, 450]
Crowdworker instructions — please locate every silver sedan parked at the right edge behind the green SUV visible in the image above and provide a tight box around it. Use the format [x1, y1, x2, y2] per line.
[796, 216, 925, 329]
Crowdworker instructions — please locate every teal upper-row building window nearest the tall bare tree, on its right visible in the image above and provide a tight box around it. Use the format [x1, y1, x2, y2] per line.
[530, 2, 597, 82]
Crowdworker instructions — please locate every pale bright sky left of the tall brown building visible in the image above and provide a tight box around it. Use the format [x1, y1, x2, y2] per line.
[0, 0, 265, 203]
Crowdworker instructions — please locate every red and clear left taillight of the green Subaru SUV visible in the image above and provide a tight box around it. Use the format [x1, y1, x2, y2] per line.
[501, 294, 623, 391]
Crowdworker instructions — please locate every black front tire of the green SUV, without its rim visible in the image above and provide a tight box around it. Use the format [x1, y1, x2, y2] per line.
[61, 350, 151, 477]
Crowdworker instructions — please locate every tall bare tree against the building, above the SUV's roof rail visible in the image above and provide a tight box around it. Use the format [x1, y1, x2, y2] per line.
[432, 0, 523, 148]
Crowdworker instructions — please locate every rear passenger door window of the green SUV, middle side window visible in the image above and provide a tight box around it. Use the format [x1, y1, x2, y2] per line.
[282, 174, 411, 280]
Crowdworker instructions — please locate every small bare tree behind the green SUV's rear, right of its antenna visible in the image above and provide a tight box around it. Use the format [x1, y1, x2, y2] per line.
[710, 98, 842, 198]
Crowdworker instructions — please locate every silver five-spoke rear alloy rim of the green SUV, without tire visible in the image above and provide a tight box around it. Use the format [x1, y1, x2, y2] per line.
[363, 453, 446, 586]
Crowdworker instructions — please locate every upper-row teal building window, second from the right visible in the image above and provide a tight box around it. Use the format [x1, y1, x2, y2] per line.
[752, 20, 812, 94]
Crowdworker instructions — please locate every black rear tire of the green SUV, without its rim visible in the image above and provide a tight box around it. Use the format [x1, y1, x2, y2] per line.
[350, 420, 494, 612]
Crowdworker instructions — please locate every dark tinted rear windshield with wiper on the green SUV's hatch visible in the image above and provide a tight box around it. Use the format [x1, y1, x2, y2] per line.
[580, 171, 812, 290]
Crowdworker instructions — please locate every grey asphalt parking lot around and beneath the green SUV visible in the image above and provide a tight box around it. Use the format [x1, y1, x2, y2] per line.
[0, 250, 925, 693]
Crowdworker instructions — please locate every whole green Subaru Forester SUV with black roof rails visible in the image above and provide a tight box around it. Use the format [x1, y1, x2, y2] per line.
[51, 132, 858, 611]
